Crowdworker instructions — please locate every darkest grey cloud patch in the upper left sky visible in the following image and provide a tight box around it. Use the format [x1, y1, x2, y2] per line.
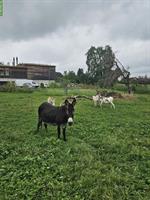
[0, 0, 79, 40]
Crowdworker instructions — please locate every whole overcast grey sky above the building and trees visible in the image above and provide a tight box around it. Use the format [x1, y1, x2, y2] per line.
[0, 0, 150, 76]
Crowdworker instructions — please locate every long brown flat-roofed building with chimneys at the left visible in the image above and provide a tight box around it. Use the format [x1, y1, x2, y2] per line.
[0, 57, 56, 83]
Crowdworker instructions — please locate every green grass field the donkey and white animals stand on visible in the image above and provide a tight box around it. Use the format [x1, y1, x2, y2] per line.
[0, 89, 150, 200]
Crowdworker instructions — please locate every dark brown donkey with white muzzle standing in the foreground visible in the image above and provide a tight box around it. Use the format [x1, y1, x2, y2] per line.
[37, 98, 76, 141]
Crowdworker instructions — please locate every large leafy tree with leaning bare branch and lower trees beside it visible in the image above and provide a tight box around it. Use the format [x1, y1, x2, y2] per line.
[57, 45, 148, 93]
